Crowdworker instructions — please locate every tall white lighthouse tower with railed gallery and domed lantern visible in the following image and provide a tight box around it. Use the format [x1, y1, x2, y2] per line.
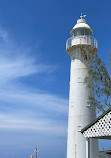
[66, 15, 98, 158]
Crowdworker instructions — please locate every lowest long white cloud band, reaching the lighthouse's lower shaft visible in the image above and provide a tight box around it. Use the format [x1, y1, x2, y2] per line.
[0, 114, 66, 136]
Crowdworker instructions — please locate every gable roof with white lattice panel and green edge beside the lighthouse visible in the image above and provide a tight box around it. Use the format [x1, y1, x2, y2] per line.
[81, 108, 111, 139]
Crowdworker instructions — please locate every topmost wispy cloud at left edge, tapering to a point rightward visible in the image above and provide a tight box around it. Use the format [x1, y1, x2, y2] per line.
[0, 28, 57, 83]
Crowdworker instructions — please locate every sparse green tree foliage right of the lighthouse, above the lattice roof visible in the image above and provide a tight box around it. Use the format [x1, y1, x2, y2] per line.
[85, 54, 111, 111]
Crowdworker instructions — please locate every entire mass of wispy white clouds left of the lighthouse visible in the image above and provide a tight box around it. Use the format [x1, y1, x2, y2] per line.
[0, 29, 68, 136]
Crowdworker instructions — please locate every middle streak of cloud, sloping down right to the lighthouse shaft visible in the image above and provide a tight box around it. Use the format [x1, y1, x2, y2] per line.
[0, 88, 68, 115]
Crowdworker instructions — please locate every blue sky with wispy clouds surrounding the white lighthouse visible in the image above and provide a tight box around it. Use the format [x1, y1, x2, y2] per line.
[0, 0, 111, 158]
